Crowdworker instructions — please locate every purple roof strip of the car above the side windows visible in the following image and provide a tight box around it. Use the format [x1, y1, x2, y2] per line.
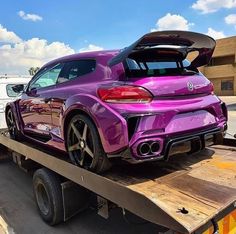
[43, 50, 120, 67]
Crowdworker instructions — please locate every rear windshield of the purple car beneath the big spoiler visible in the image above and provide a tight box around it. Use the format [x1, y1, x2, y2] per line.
[125, 49, 198, 77]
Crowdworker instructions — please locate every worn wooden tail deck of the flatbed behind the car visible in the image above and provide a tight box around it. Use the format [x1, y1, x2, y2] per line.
[106, 146, 236, 232]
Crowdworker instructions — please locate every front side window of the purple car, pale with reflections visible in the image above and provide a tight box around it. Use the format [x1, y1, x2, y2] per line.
[29, 64, 63, 89]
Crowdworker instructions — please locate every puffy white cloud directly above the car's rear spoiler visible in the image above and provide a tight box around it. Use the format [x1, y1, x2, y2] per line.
[151, 13, 194, 32]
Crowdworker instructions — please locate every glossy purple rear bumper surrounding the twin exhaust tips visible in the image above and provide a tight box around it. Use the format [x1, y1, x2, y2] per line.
[100, 95, 227, 156]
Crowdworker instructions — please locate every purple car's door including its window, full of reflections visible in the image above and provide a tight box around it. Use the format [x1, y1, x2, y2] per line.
[19, 63, 63, 138]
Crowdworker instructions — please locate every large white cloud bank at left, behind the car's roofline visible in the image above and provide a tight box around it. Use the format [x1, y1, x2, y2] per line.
[0, 25, 75, 75]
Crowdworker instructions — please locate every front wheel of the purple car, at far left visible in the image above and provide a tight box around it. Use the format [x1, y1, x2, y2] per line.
[6, 108, 22, 140]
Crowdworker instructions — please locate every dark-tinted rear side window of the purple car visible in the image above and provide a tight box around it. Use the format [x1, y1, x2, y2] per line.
[58, 59, 96, 83]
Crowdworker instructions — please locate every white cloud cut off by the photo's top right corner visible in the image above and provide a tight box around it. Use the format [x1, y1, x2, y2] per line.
[192, 0, 236, 14]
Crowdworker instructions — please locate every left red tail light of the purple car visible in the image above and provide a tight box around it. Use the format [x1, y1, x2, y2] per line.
[98, 85, 152, 103]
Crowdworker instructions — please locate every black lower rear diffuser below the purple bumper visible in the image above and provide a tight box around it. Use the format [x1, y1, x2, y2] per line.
[121, 127, 227, 164]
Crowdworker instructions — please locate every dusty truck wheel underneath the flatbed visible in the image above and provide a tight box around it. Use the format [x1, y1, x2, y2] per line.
[33, 168, 64, 225]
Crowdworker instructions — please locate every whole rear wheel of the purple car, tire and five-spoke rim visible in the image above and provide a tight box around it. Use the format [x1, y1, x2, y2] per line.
[66, 114, 111, 174]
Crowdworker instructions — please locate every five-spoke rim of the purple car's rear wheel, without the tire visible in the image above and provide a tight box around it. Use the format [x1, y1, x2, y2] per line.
[68, 118, 94, 169]
